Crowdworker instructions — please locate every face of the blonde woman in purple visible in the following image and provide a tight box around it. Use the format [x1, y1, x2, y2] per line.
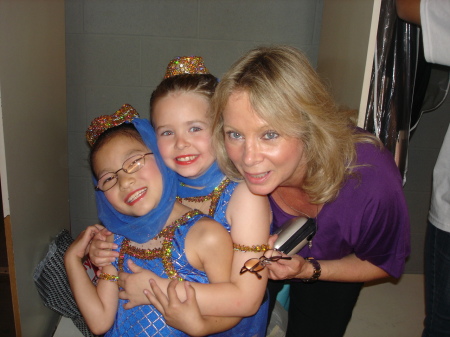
[223, 91, 306, 195]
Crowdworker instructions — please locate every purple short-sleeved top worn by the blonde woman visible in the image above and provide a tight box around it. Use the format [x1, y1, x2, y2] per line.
[270, 143, 410, 278]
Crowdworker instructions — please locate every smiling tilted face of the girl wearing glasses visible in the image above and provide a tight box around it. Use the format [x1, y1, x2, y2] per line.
[93, 135, 163, 216]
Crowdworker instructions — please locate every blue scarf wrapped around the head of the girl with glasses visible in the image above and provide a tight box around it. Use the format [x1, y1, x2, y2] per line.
[94, 118, 177, 243]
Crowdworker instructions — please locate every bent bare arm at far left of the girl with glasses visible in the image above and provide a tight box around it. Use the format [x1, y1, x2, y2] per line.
[64, 226, 118, 334]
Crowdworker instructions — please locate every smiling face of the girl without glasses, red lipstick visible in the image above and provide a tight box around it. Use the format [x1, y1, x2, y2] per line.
[152, 92, 215, 178]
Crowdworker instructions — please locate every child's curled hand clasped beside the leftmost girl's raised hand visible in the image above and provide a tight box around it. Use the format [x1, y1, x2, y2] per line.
[89, 225, 119, 268]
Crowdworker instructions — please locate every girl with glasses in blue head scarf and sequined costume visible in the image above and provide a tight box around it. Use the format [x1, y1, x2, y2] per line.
[65, 105, 256, 336]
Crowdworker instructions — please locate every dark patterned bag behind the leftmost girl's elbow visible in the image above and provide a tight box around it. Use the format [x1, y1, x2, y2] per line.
[33, 229, 94, 337]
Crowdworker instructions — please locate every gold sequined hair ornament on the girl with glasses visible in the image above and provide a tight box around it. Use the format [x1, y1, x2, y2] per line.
[86, 104, 139, 146]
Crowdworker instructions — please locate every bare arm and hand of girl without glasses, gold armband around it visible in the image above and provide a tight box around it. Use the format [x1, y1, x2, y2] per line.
[120, 183, 271, 317]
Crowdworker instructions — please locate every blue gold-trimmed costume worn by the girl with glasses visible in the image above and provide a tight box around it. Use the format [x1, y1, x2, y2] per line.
[105, 210, 208, 337]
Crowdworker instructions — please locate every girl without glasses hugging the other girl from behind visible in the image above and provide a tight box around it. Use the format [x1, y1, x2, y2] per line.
[90, 57, 271, 336]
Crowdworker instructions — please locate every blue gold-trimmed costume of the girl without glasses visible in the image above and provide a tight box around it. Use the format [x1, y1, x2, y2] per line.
[179, 179, 269, 337]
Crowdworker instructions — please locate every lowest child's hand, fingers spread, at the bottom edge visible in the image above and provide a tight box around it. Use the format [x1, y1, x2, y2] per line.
[144, 279, 206, 336]
